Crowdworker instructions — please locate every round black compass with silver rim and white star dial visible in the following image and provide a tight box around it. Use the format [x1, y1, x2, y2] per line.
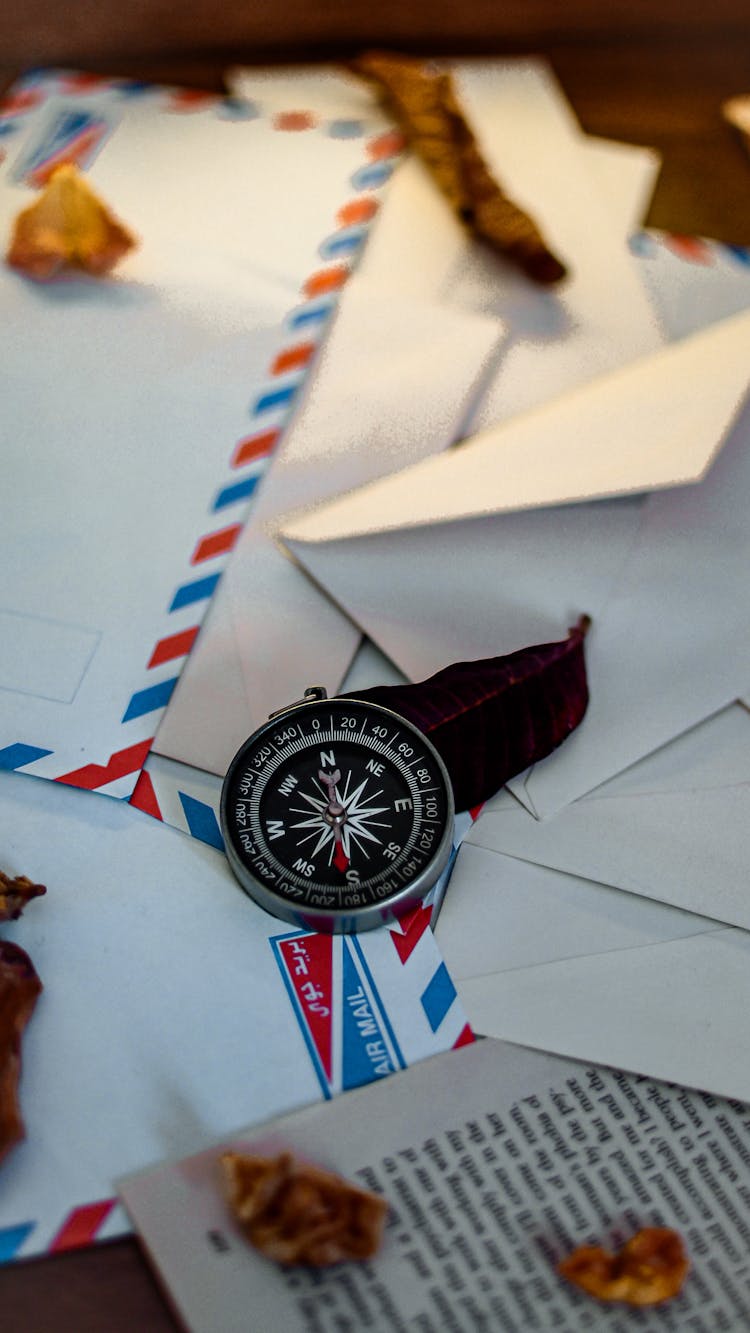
[221, 698, 453, 930]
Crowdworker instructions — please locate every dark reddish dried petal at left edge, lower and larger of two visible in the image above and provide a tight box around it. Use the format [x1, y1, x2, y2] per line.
[0, 940, 41, 1162]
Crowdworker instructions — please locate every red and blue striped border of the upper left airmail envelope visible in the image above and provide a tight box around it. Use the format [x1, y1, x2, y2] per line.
[0, 71, 402, 794]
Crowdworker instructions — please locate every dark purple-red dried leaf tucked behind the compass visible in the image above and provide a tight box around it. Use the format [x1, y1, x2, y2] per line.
[352, 616, 590, 810]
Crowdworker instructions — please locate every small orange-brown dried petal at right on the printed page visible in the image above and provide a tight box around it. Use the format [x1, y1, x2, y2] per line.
[558, 1226, 690, 1305]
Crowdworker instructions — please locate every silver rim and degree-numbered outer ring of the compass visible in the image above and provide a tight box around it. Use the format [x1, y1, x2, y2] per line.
[220, 690, 454, 933]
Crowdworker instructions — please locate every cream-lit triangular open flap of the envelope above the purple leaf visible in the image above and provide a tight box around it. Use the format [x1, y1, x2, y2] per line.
[282, 312, 750, 547]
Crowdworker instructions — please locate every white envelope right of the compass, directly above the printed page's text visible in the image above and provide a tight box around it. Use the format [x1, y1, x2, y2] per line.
[437, 844, 750, 1100]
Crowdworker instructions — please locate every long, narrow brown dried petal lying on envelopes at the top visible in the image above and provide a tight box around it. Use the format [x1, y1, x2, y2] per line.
[354, 52, 566, 285]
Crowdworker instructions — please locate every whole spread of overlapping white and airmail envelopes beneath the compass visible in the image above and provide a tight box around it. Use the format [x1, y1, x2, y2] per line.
[0, 60, 750, 1257]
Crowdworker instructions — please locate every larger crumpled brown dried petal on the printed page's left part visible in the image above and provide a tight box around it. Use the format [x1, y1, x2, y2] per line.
[221, 1152, 388, 1268]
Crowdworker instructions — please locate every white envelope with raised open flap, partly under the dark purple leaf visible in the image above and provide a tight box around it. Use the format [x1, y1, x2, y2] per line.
[282, 286, 750, 817]
